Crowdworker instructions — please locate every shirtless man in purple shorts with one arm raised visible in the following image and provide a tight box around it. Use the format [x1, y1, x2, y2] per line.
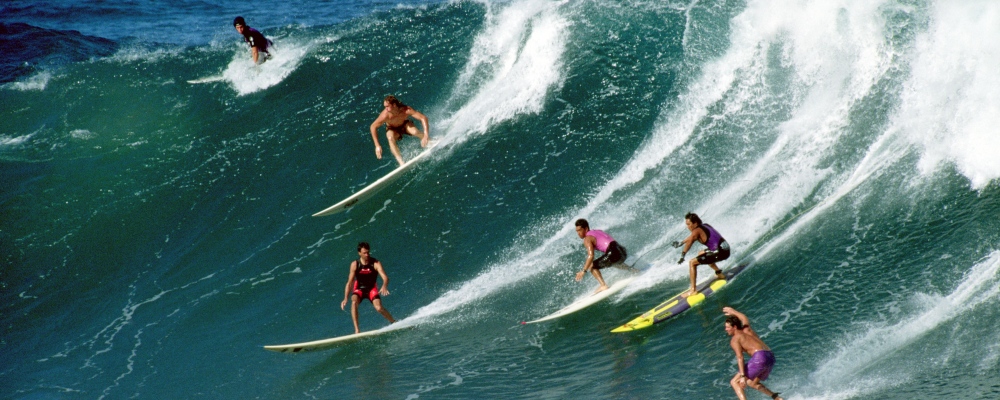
[722, 307, 781, 400]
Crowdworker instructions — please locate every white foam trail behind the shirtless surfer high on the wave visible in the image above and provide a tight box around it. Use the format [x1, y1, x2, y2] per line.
[442, 0, 569, 143]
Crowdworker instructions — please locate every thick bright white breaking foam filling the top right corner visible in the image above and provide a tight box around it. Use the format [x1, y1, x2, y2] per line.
[894, 1, 1000, 189]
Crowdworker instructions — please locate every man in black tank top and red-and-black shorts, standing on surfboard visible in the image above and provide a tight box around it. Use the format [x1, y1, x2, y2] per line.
[340, 242, 396, 333]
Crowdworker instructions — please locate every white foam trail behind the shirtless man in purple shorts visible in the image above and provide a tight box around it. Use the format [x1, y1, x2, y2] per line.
[795, 251, 1000, 399]
